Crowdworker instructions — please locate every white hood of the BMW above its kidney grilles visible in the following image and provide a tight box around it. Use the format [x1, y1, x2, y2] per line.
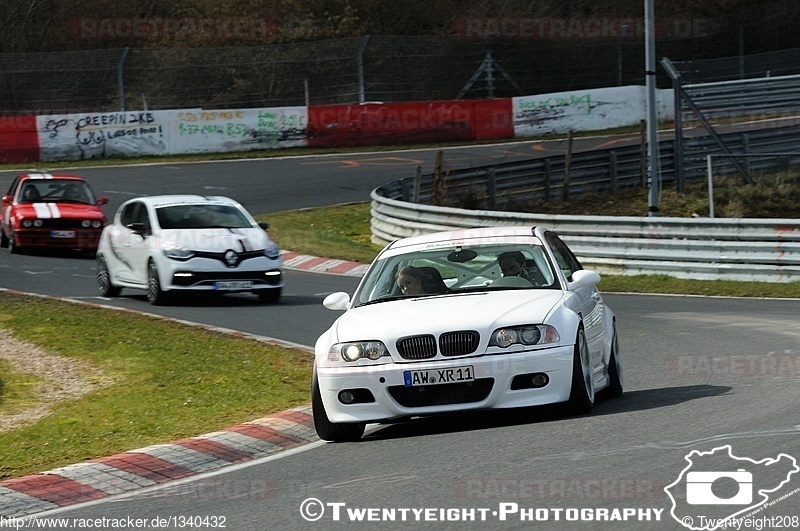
[336, 290, 563, 348]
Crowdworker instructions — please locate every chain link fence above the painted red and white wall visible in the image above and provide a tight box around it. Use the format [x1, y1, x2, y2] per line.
[0, 0, 800, 116]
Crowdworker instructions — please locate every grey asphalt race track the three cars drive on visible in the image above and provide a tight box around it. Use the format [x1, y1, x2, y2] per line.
[0, 140, 800, 530]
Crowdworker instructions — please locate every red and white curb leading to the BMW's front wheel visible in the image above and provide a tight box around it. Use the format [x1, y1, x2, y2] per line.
[0, 405, 319, 521]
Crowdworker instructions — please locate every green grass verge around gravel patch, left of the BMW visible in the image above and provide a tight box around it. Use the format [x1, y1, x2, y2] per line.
[0, 293, 312, 479]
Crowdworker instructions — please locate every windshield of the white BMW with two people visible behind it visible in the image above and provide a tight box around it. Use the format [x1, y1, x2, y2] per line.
[354, 240, 558, 306]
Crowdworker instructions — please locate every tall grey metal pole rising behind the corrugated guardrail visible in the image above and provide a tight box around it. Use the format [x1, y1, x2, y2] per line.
[644, 0, 661, 216]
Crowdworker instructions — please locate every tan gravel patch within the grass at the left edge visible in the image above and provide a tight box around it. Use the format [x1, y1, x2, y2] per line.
[0, 328, 112, 433]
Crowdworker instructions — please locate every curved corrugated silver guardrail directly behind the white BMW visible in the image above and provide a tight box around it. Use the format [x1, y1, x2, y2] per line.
[371, 190, 800, 282]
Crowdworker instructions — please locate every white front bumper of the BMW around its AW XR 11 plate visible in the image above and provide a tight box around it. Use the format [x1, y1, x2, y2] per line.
[317, 346, 574, 422]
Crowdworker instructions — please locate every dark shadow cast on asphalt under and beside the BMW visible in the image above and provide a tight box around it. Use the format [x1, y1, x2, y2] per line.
[362, 385, 732, 441]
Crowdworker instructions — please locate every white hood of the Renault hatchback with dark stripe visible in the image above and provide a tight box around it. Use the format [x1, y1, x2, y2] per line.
[160, 227, 271, 253]
